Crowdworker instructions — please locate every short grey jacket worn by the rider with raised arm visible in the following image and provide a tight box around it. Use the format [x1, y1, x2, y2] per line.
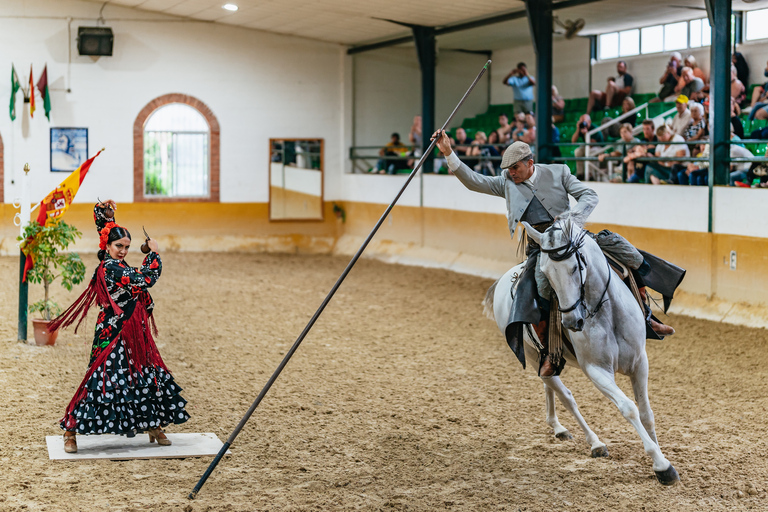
[447, 153, 598, 235]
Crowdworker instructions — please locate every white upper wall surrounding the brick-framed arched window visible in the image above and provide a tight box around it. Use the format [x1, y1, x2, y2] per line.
[0, 0, 346, 202]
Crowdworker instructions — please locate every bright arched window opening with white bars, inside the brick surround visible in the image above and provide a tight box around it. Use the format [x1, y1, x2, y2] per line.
[144, 103, 210, 198]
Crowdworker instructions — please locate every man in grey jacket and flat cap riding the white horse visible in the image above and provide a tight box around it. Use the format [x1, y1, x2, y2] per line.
[432, 131, 684, 377]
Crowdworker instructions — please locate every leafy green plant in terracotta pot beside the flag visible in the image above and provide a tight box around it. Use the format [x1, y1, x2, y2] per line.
[18, 221, 85, 345]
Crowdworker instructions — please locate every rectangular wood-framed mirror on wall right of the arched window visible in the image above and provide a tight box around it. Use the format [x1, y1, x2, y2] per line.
[269, 139, 323, 220]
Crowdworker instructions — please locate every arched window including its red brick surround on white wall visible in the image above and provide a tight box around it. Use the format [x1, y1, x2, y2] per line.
[133, 93, 219, 202]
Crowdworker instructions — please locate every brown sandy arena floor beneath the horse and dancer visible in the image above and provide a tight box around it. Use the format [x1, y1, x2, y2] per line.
[0, 253, 768, 512]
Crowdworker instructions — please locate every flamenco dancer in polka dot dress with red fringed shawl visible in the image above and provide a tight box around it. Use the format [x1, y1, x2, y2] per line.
[50, 199, 189, 453]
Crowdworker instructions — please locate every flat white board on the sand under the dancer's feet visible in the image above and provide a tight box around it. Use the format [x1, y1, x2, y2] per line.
[45, 432, 231, 460]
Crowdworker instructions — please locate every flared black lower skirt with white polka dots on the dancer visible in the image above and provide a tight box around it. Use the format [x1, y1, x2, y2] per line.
[61, 340, 189, 437]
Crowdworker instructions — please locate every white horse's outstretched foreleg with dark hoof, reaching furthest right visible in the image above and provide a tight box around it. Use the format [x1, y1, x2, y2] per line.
[582, 364, 680, 485]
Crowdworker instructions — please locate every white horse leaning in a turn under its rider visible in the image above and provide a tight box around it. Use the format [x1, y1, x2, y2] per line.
[484, 217, 679, 485]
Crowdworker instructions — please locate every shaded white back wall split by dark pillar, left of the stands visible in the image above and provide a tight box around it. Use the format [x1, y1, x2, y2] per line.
[352, 47, 488, 146]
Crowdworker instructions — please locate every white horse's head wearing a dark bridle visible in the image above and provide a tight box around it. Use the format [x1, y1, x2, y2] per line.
[523, 215, 600, 332]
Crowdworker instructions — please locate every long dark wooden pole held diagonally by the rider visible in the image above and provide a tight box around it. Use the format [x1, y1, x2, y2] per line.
[188, 60, 491, 500]
